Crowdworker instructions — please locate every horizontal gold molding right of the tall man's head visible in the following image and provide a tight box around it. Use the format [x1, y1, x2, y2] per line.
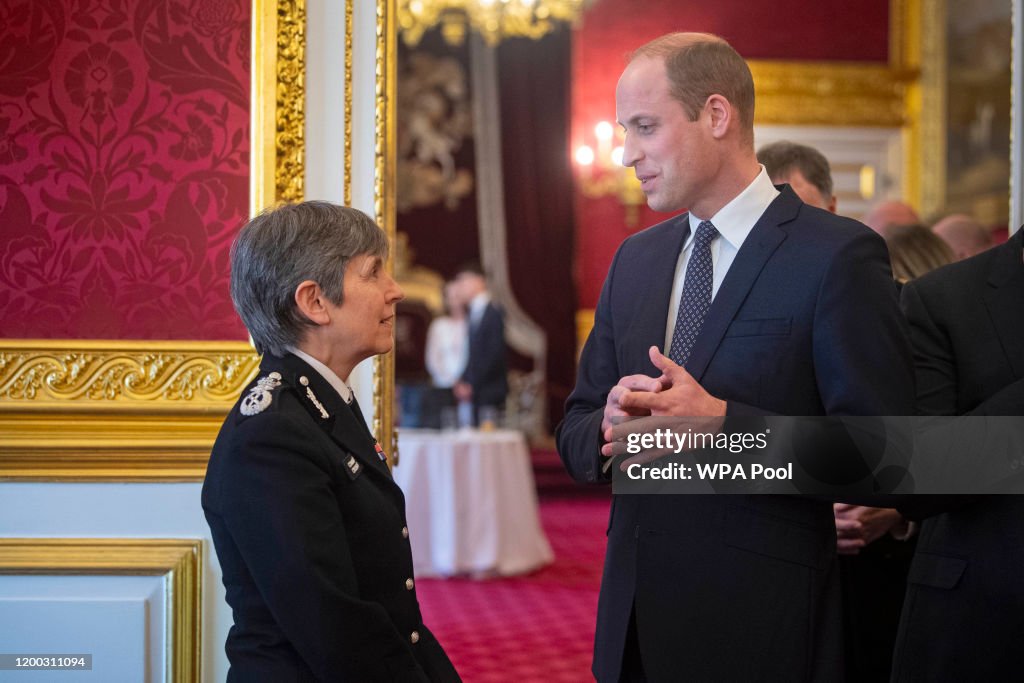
[749, 59, 916, 128]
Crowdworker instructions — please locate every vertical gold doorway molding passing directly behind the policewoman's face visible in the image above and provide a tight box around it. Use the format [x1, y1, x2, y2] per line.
[372, 0, 398, 466]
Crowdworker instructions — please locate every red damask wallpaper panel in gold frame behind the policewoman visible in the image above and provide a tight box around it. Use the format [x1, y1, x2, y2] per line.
[0, 0, 251, 339]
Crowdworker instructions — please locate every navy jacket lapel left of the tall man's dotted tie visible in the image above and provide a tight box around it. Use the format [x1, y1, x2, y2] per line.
[622, 218, 690, 374]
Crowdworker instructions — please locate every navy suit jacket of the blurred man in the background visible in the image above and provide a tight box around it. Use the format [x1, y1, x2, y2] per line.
[462, 302, 509, 409]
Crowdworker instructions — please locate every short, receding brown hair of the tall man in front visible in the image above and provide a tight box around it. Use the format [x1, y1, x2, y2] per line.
[629, 33, 754, 142]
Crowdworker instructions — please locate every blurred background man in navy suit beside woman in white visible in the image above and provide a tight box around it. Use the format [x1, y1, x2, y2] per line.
[453, 263, 509, 422]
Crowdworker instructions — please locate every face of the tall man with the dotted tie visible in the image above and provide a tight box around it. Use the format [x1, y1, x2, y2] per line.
[615, 57, 716, 218]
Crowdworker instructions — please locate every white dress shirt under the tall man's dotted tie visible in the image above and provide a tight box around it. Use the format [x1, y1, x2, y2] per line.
[665, 166, 779, 355]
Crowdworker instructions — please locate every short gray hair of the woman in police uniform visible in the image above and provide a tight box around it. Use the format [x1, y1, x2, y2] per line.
[231, 201, 388, 356]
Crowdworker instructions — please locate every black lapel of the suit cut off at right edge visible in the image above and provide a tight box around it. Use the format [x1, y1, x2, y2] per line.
[985, 229, 1024, 378]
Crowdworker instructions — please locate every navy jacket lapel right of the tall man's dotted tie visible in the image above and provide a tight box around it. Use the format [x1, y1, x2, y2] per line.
[686, 189, 800, 382]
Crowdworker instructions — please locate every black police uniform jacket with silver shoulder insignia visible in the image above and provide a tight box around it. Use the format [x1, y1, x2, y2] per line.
[203, 354, 459, 683]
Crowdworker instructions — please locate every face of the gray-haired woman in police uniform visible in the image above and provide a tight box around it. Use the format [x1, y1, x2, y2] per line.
[328, 254, 403, 361]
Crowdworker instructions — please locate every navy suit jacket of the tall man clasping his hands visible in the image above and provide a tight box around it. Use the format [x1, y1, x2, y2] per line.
[557, 186, 913, 681]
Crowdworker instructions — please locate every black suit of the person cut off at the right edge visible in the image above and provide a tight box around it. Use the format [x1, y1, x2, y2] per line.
[893, 230, 1024, 681]
